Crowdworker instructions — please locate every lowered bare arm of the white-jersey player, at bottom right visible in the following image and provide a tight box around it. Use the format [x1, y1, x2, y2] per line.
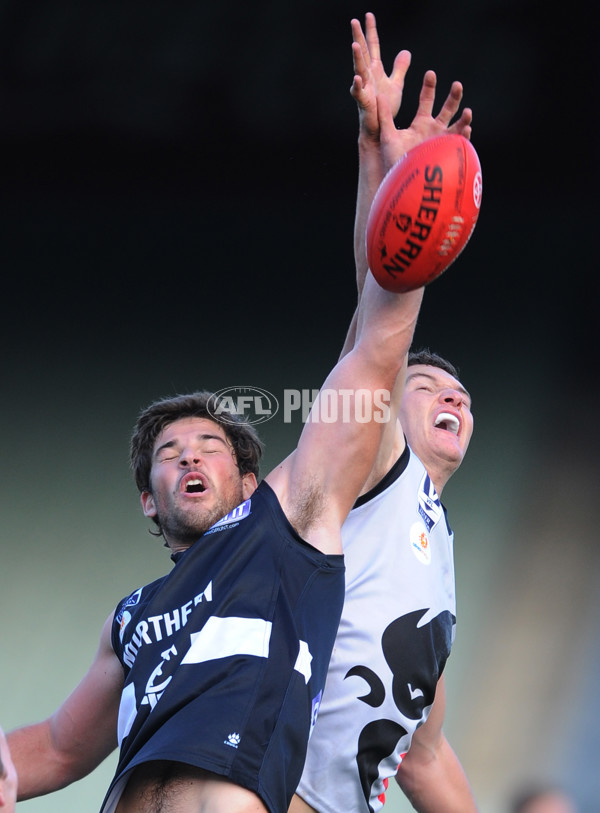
[396, 678, 477, 813]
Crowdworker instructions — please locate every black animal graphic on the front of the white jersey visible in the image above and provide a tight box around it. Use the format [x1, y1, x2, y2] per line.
[346, 609, 456, 813]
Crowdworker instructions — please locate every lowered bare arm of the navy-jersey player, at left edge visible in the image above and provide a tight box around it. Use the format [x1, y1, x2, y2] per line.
[7, 615, 123, 801]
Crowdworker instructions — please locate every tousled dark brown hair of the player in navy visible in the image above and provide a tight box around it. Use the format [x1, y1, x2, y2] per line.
[130, 391, 263, 493]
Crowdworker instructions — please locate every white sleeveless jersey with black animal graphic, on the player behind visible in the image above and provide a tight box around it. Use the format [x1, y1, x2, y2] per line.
[297, 447, 456, 813]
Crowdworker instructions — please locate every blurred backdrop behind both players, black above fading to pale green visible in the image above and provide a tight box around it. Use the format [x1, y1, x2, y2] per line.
[0, 0, 600, 813]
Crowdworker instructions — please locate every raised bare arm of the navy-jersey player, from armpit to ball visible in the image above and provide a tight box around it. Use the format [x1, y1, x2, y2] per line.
[266, 92, 423, 553]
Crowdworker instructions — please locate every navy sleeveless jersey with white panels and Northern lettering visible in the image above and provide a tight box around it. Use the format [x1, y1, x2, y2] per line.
[102, 482, 344, 813]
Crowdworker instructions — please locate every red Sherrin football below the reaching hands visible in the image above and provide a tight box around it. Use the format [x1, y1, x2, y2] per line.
[366, 134, 482, 291]
